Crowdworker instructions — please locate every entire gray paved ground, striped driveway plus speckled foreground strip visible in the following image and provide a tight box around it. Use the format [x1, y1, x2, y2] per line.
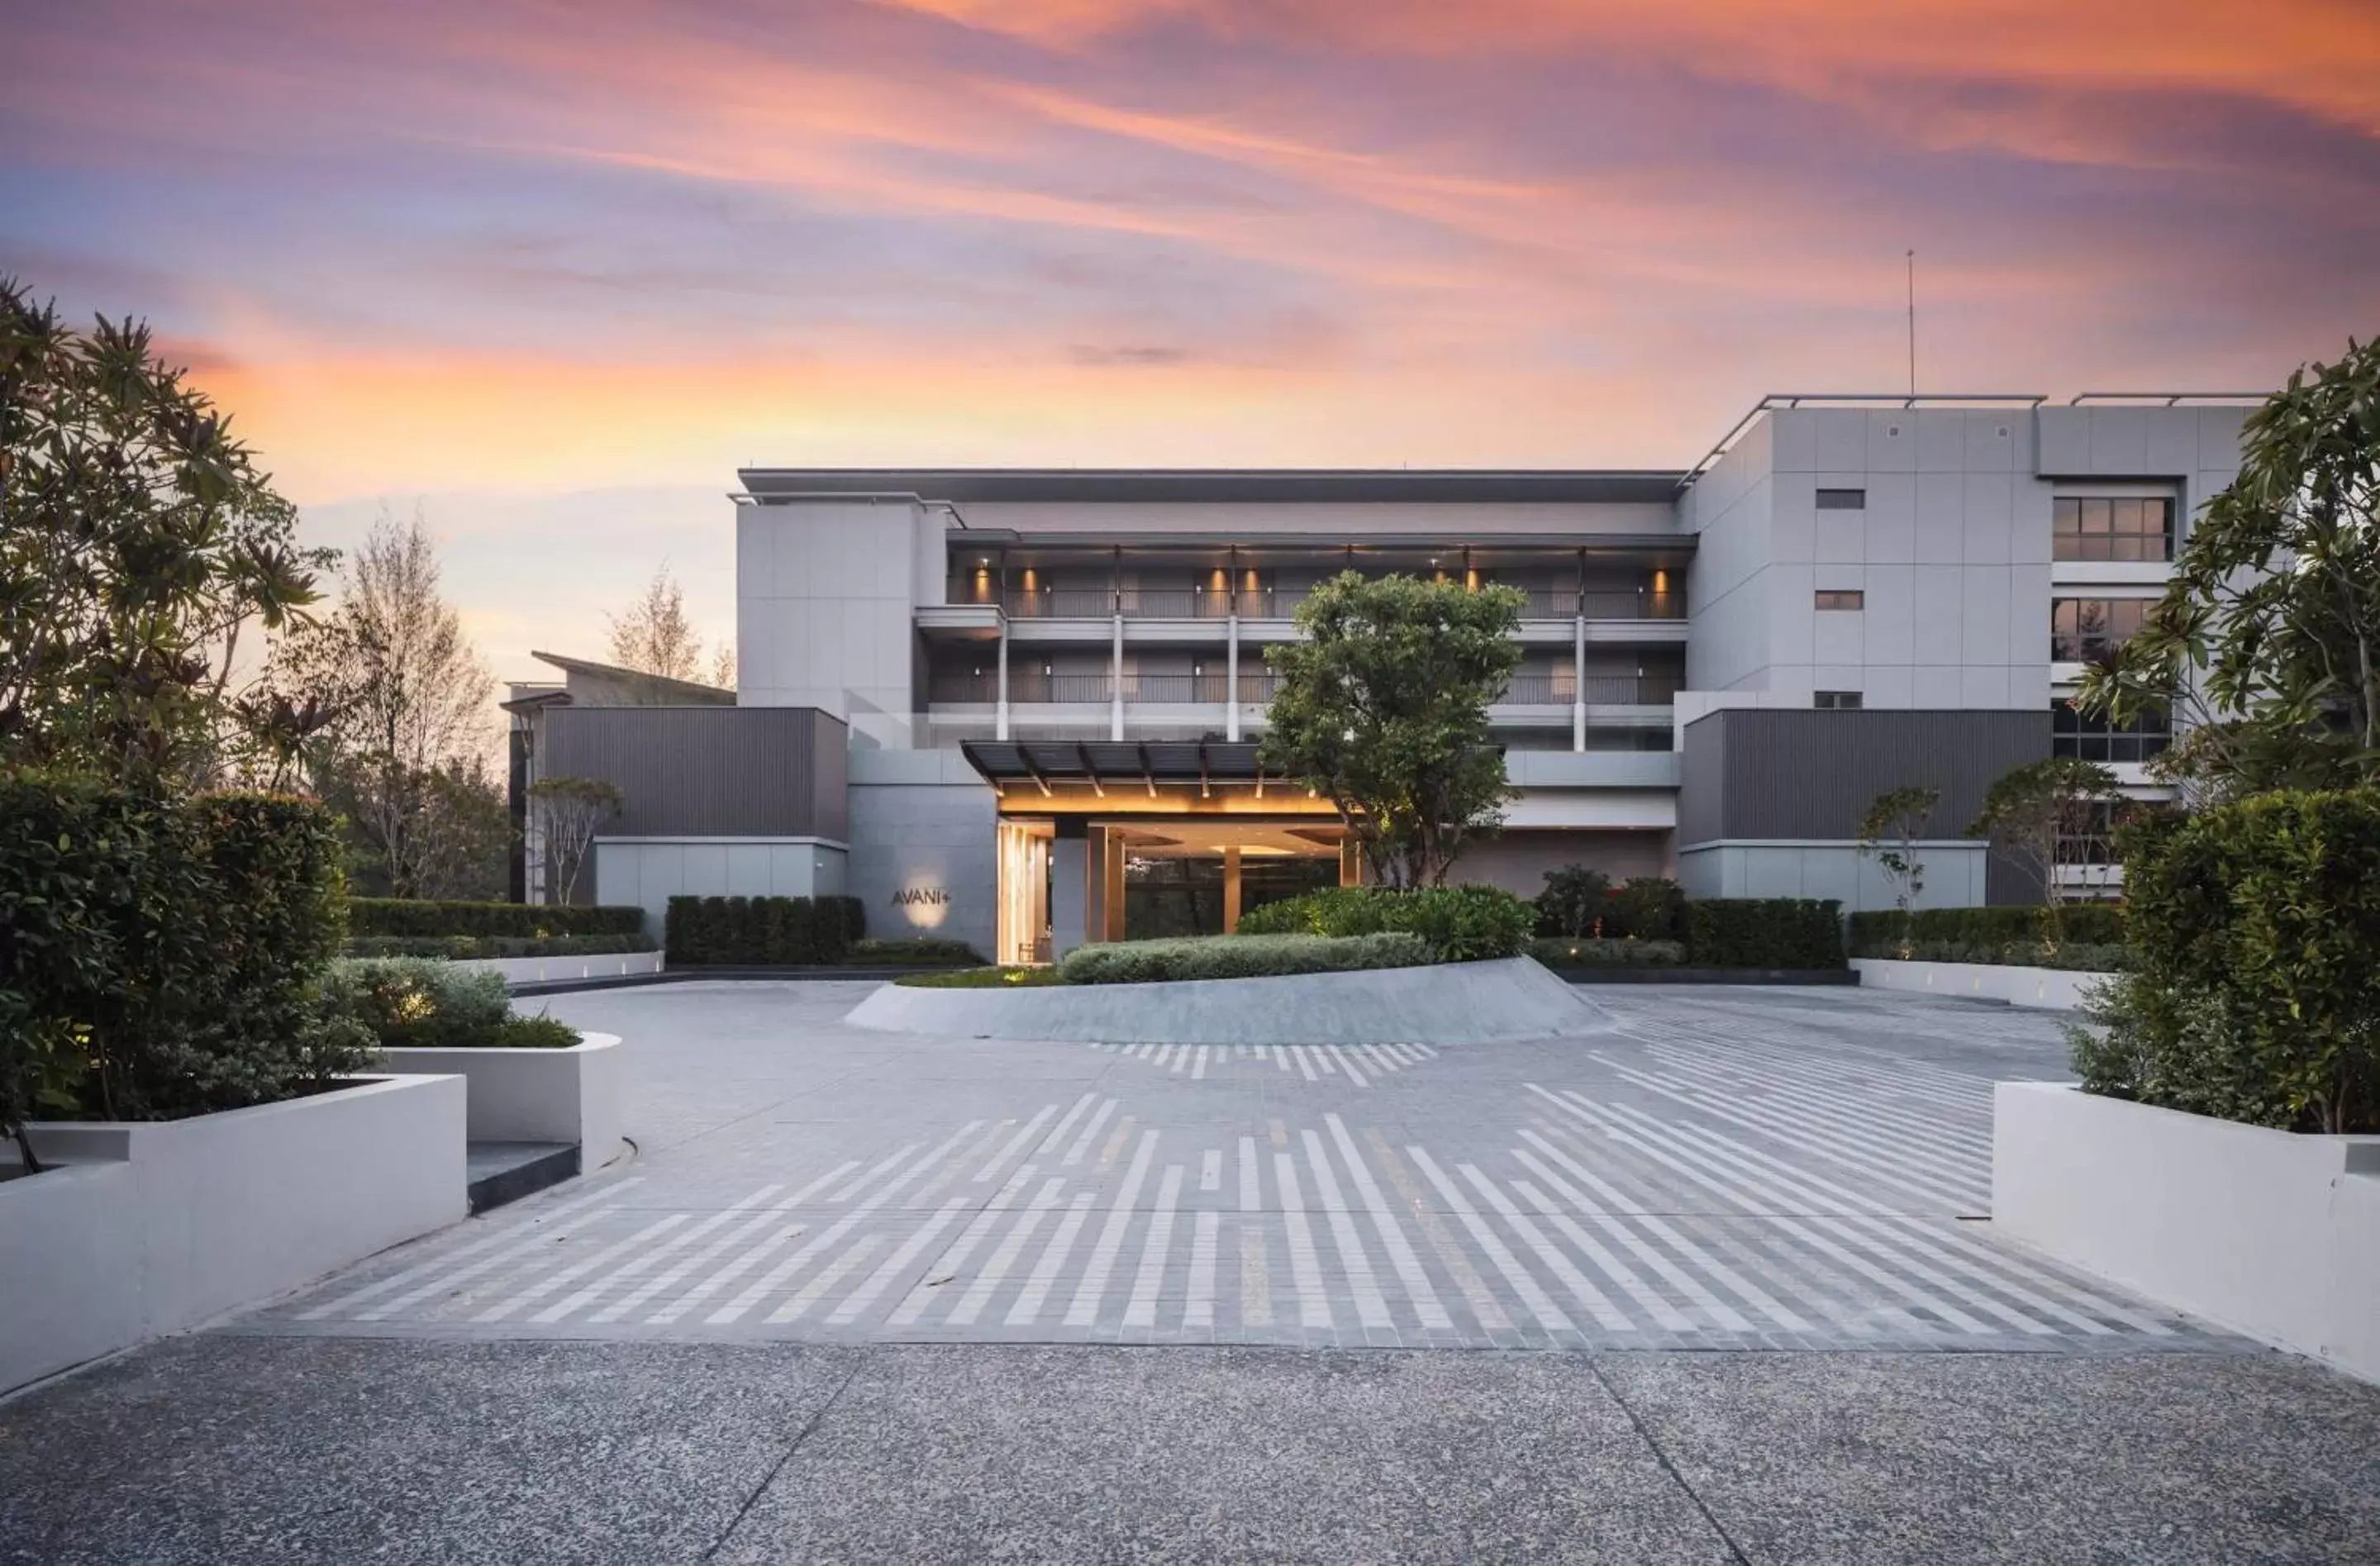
[0, 983, 2380, 1566]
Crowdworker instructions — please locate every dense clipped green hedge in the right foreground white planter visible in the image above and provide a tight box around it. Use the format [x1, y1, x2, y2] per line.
[2068, 788, 2380, 1133]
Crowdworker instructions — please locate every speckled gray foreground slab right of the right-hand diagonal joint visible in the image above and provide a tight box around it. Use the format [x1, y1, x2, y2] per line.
[1597, 1354, 2380, 1566]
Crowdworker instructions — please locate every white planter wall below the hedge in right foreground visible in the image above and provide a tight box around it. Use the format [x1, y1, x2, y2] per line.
[1992, 1083, 2380, 1383]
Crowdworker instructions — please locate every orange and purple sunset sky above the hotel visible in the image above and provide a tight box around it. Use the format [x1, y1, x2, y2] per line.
[0, 0, 2380, 676]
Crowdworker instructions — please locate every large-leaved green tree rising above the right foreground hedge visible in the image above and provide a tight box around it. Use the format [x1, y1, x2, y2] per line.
[2075, 338, 2380, 797]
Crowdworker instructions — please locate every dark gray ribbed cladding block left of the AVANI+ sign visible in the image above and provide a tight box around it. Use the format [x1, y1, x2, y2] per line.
[538, 707, 850, 840]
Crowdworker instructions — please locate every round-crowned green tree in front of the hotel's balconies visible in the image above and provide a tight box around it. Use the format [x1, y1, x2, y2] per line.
[1259, 571, 1528, 888]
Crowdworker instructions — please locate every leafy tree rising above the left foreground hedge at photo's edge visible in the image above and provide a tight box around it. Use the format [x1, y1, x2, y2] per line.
[0, 278, 336, 783]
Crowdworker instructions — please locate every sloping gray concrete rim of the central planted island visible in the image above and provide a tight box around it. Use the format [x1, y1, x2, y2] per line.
[845, 957, 1611, 1045]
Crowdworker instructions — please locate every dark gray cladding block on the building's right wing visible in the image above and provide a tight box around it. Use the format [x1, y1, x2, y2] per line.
[1678, 707, 2049, 847]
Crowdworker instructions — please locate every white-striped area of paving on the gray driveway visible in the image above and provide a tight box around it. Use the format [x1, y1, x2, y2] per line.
[262, 1028, 2211, 1349]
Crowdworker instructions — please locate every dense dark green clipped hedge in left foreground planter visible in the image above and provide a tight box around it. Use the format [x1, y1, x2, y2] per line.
[0, 773, 374, 1151]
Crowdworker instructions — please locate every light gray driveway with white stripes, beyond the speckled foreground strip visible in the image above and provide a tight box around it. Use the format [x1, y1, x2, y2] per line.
[248, 983, 2218, 1352]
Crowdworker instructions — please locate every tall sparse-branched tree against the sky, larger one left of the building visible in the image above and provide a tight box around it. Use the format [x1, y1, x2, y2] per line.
[300, 499, 509, 897]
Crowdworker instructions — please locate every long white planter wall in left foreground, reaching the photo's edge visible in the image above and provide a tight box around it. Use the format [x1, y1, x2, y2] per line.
[0, 1076, 464, 1390]
